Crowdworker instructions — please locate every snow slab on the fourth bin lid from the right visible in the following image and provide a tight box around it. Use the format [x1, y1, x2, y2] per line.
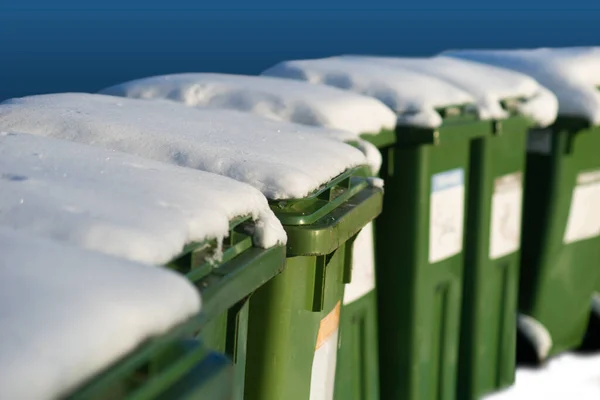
[100, 73, 396, 138]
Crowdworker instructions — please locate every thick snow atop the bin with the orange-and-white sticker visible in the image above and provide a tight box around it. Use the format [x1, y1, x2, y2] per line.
[0, 93, 367, 200]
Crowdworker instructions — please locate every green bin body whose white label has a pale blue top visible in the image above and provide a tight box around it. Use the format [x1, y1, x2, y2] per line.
[365, 119, 489, 400]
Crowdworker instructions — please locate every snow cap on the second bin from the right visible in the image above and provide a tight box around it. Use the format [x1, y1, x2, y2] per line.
[343, 56, 558, 126]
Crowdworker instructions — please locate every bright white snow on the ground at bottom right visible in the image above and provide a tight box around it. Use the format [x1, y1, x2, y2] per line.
[484, 353, 600, 400]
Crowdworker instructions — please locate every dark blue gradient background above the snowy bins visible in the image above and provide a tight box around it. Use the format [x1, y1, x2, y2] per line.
[0, 0, 600, 100]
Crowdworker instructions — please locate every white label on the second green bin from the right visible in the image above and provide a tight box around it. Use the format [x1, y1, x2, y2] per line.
[490, 172, 523, 260]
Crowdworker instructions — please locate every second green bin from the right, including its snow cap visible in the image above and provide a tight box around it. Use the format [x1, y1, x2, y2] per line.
[350, 57, 556, 399]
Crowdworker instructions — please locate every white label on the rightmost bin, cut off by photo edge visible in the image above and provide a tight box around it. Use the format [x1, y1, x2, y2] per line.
[563, 170, 600, 244]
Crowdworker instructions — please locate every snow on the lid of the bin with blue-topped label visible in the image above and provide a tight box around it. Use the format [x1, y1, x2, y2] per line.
[262, 57, 474, 127]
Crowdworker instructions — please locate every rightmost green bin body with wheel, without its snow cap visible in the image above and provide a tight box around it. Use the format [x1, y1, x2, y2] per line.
[518, 117, 600, 363]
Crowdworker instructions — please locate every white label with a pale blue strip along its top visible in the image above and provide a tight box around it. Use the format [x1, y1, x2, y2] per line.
[429, 169, 465, 263]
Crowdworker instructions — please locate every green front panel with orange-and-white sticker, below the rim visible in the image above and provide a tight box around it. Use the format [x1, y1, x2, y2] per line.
[246, 252, 346, 400]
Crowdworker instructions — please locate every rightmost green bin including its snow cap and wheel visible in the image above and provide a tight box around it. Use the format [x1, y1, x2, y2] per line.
[448, 47, 600, 364]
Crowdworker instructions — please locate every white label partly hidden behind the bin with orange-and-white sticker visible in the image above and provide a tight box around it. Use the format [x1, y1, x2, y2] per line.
[344, 222, 375, 304]
